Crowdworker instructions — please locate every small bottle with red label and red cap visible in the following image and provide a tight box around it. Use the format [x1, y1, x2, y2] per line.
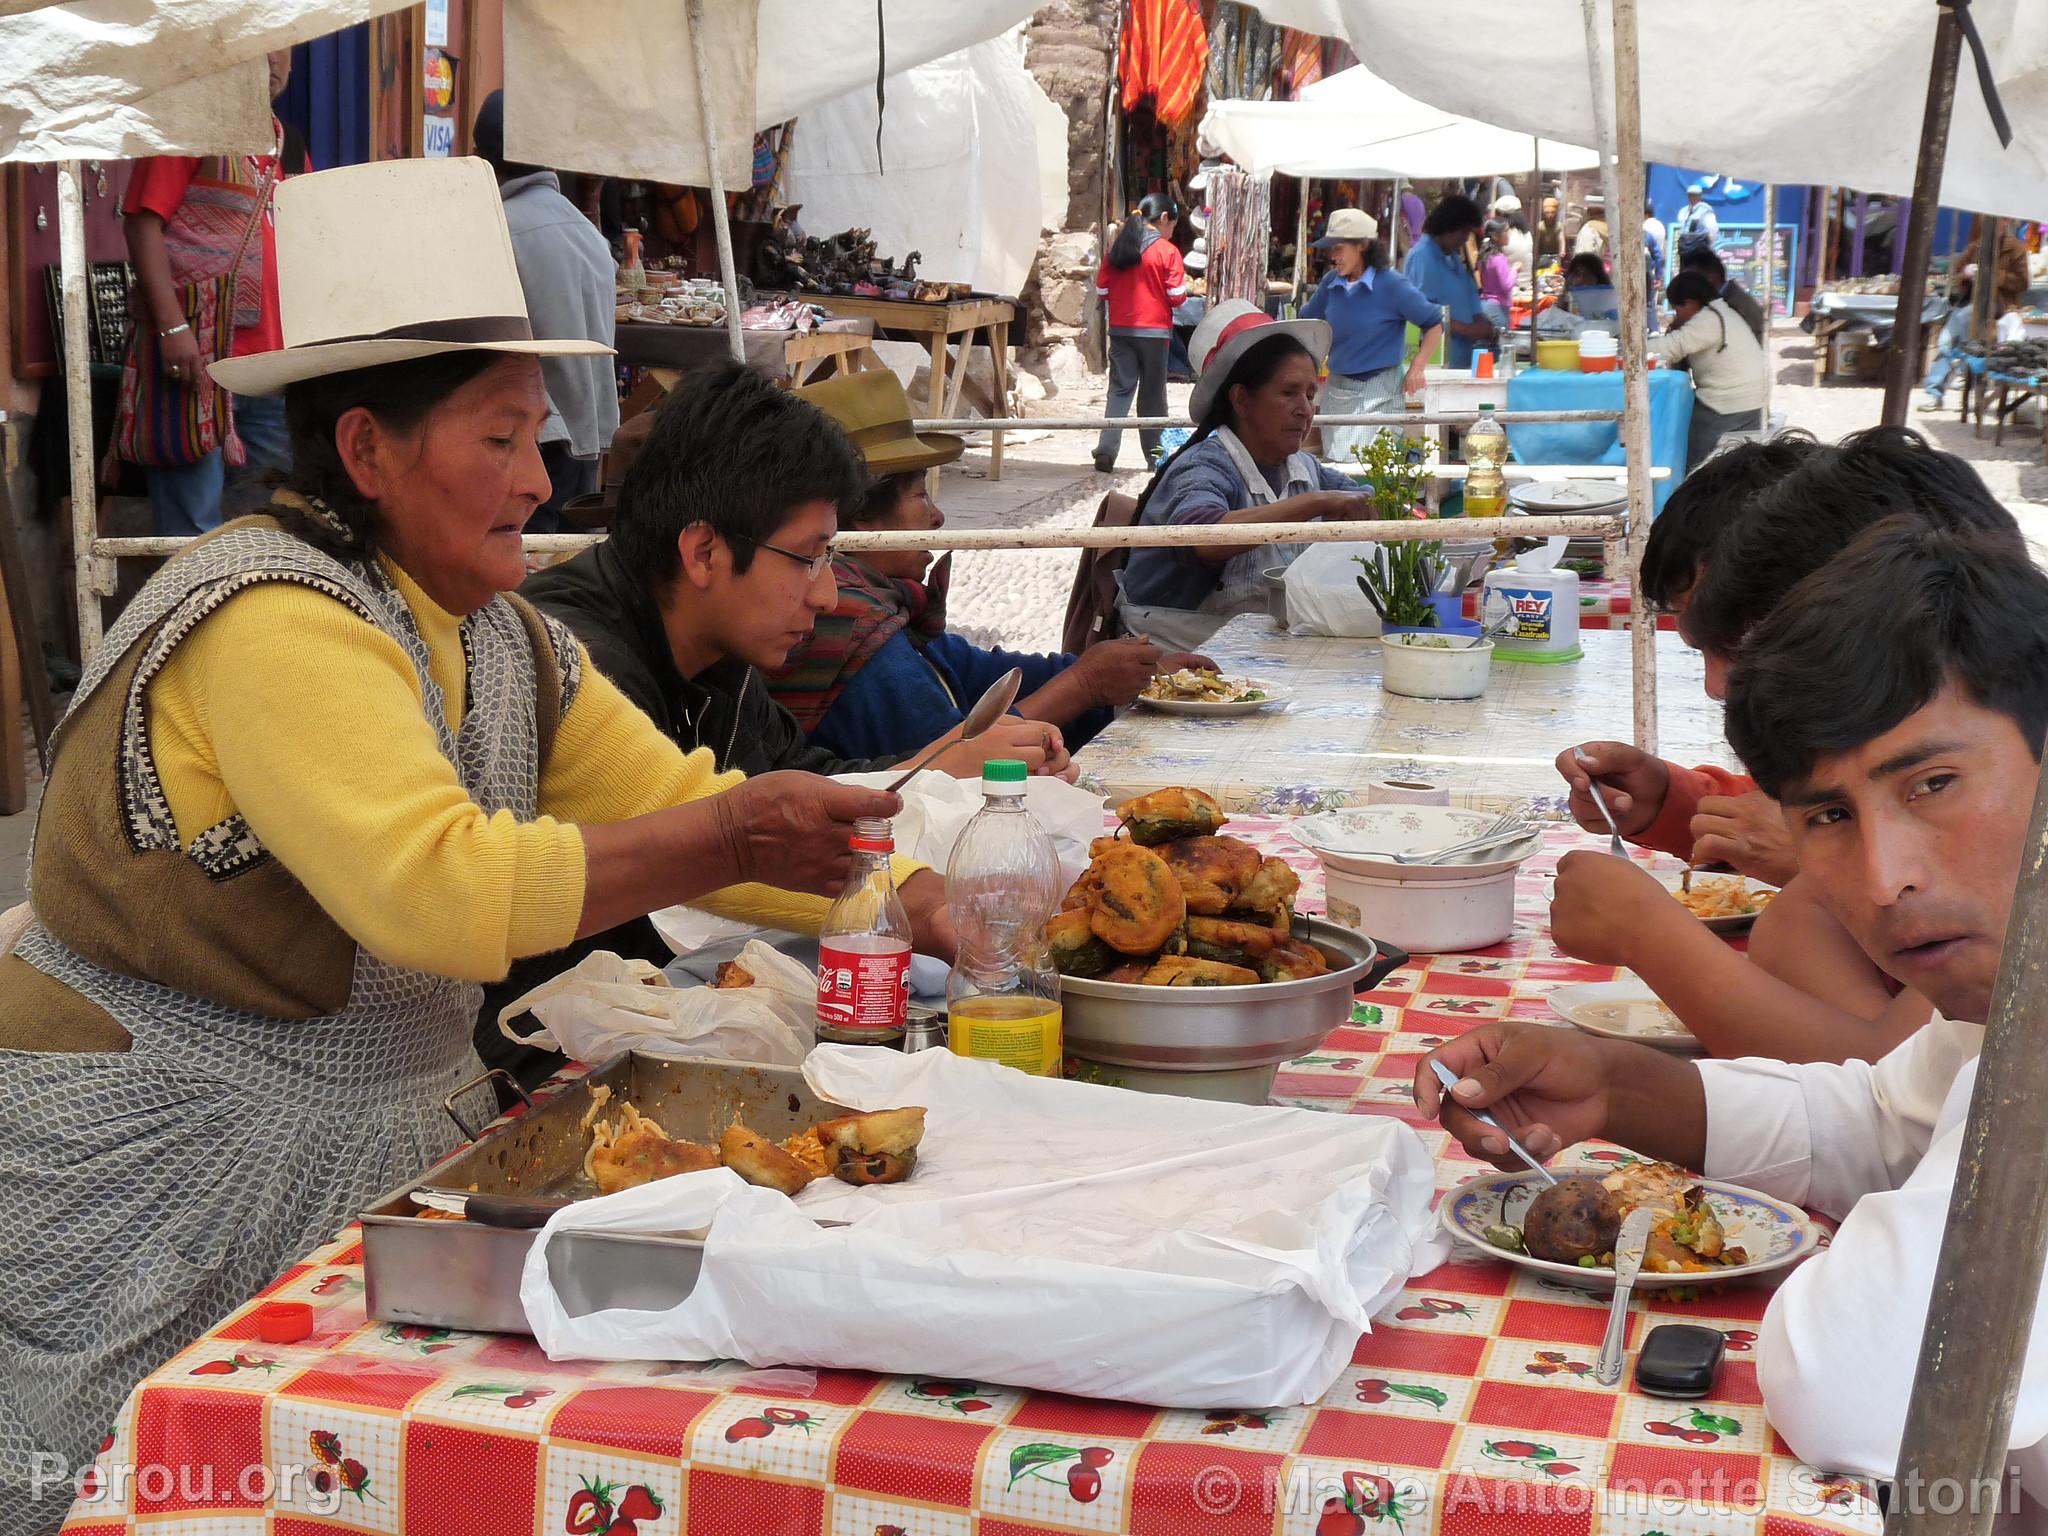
[817, 817, 909, 1044]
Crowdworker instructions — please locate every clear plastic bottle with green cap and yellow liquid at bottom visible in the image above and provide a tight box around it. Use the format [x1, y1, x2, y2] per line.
[946, 758, 1063, 1077]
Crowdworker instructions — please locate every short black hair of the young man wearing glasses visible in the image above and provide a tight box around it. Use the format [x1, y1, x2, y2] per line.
[612, 358, 866, 590]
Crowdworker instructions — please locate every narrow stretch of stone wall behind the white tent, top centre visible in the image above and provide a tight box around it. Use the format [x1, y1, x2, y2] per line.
[1018, 0, 1122, 414]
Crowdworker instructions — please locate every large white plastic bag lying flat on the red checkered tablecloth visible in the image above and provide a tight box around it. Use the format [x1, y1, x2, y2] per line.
[520, 1047, 1448, 1407]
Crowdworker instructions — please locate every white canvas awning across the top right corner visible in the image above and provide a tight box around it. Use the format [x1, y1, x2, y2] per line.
[1260, 0, 2048, 219]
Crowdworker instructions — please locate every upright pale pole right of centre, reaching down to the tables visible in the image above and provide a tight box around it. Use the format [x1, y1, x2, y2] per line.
[1585, 0, 1657, 752]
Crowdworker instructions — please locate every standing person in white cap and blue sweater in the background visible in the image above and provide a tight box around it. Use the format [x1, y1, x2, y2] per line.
[1300, 209, 1444, 463]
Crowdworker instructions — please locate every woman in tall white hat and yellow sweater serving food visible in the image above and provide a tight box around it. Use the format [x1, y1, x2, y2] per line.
[0, 160, 944, 1530]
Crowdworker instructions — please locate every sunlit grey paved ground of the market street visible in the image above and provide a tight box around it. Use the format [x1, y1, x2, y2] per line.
[0, 324, 2048, 909]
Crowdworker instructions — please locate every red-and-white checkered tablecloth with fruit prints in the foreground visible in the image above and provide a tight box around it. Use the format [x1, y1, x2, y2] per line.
[66, 817, 1882, 1536]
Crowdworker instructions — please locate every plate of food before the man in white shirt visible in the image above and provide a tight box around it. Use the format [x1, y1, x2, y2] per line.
[1436, 1161, 1821, 1290]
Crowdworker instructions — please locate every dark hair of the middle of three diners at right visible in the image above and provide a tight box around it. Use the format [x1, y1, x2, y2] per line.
[1673, 426, 2028, 655]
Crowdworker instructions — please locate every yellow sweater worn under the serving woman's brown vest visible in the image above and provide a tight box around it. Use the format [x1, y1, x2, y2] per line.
[145, 561, 847, 981]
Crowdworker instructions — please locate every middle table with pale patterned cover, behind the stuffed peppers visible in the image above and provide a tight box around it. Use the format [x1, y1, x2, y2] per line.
[1075, 614, 1735, 817]
